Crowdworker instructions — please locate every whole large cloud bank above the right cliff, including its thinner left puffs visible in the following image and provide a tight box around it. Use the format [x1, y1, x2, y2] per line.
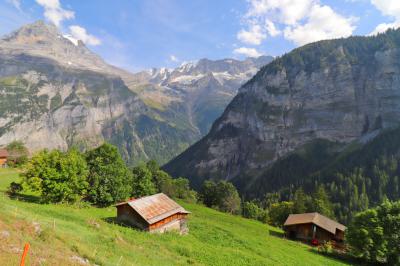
[237, 0, 356, 45]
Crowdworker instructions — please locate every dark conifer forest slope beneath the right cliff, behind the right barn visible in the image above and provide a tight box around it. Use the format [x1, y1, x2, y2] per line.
[245, 127, 400, 223]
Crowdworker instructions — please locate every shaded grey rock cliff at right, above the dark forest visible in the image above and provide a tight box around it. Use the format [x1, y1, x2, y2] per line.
[165, 28, 400, 192]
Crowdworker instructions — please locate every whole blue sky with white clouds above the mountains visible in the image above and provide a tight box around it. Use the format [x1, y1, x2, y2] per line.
[0, 0, 400, 71]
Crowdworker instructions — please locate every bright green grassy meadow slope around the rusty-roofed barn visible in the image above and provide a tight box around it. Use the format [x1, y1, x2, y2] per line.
[0, 169, 345, 266]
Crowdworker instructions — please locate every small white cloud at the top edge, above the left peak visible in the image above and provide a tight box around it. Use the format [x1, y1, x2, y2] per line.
[36, 0, 75, 27]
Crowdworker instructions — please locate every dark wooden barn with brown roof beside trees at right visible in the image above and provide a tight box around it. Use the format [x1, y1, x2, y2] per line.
[284, 212, 346, 244]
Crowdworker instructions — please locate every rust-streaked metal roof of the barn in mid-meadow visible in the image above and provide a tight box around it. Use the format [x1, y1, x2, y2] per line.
[116, 193, 190, 224]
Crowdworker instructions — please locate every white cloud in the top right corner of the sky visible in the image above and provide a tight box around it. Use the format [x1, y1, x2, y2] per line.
[371, 0, 400, 35]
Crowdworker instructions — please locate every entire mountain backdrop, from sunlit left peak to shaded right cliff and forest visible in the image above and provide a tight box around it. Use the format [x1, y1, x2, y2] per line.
[0, 21, 400, 227]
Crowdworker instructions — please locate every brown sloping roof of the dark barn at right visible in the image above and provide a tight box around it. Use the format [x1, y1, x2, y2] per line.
[284, 212, 346, 234]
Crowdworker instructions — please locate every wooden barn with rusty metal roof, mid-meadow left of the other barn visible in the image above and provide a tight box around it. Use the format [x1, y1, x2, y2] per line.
[116, 193, 190, 234]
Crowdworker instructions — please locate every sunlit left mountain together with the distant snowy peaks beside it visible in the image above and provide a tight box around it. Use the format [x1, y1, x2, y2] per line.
[0, 21, 270, 164]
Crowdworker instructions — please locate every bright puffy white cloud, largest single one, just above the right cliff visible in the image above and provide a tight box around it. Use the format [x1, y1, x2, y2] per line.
[284, 4, 355, 45]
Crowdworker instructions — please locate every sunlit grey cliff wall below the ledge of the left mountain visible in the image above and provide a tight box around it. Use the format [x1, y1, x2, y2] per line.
[0, 55, 167, 158]
